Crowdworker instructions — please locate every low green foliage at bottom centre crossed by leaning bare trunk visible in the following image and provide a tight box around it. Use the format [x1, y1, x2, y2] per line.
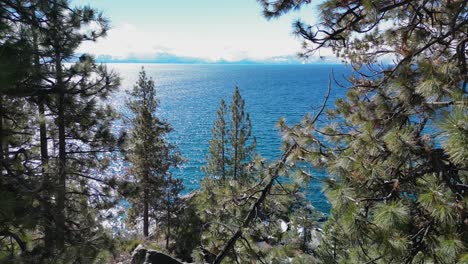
[193, 158, 317, 263]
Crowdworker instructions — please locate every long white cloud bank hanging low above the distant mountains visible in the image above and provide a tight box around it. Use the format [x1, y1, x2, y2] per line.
[78, 24, 314, 61]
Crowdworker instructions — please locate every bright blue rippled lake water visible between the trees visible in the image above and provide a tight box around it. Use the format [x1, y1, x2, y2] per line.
[109, 64, 350, 213]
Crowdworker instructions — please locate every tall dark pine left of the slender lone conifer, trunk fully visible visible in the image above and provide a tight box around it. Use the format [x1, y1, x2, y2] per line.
[38, 1, 119, 257]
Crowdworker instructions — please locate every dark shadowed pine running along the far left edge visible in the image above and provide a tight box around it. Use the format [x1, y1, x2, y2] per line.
[0, 1, 47, 261]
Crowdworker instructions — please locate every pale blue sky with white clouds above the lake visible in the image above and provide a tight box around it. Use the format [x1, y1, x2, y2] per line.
[72, 0, 328, 62]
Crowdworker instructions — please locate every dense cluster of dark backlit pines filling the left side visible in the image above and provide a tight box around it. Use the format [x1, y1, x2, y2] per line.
[0, 0, 119, 263]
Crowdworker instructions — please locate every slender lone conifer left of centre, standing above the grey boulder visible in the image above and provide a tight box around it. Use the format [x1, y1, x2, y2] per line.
[126, 69, 181, 237]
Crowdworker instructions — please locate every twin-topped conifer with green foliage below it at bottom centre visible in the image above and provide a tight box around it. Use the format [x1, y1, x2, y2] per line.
[192, 87, 317, 263]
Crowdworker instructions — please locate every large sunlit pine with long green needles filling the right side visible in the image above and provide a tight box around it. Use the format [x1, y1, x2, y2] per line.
[260, 0, 468, 263]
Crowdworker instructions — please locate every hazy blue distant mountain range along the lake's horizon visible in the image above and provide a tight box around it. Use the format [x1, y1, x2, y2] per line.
[88, 53, 340, 64]
